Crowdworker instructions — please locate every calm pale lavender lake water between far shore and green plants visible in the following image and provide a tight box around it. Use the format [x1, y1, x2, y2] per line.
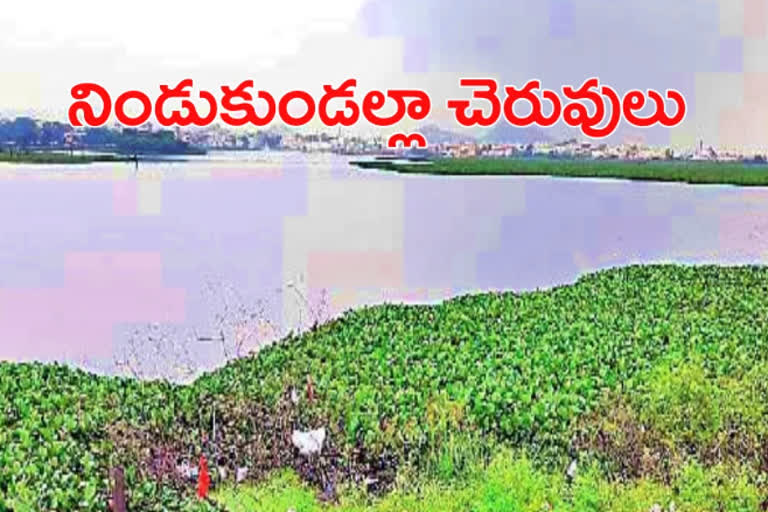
[0, 152, 768, 380]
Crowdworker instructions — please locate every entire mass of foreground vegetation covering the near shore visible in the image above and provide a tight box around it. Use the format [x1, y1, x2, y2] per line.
[0, 266, 768, 512]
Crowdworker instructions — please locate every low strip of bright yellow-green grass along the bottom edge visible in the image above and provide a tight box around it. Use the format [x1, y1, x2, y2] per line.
[215, 450, 762, 512]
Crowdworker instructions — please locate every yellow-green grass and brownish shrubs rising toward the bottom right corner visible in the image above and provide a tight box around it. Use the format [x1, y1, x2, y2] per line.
[217, 357, 768, 512]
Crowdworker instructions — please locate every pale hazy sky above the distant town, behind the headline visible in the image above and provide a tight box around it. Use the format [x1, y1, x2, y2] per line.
[0, 0, 768, 149]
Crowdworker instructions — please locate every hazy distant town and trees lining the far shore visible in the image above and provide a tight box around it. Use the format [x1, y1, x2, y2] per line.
[0, 117, 766, 163]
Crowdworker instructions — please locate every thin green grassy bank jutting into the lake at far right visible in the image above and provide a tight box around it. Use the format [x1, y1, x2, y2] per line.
[354, 158, 768, 186]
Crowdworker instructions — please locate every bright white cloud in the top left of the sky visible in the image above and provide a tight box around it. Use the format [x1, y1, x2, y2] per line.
[0, 0, 362, 65]
